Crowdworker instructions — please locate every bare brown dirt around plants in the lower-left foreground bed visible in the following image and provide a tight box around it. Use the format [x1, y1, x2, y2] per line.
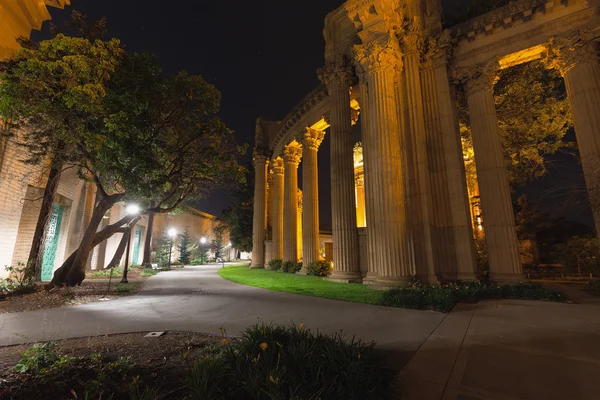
[0, 333, 222, 400]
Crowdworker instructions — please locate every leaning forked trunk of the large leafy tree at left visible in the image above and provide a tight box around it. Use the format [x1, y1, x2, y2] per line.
[51, 195, 129, 286]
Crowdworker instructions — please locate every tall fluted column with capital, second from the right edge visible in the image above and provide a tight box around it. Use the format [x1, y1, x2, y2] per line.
[466, 62, 524, 282]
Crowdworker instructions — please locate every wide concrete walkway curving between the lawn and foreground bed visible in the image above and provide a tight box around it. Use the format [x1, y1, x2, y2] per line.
[0, 266, 600, 400]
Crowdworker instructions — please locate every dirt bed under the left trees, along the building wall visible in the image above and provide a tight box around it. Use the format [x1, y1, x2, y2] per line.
[0, 279, 142, 314]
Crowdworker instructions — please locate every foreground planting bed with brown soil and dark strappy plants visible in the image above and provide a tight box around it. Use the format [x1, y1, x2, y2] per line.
[0, 324, 394, 400]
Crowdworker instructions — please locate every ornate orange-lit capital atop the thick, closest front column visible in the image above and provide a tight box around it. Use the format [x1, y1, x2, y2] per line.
[354, 35, 402, 74]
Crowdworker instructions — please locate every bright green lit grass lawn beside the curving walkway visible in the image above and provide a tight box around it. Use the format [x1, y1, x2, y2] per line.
[219, 264, 382, 304]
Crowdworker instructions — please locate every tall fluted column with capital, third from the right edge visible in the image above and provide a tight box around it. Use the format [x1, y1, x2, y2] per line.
[421, 43, 476, 281]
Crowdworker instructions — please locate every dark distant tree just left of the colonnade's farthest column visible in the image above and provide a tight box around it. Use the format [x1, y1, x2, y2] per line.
[219, 164, 254, 252]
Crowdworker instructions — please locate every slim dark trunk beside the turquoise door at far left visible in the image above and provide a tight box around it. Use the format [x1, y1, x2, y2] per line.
[27, 158, 62, 281]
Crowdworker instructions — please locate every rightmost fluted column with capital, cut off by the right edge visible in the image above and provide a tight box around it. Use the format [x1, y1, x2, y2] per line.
[547, 30, 600, 235]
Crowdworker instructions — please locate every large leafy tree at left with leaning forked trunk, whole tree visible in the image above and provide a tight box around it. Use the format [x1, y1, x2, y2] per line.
[0, 34, 243, 286]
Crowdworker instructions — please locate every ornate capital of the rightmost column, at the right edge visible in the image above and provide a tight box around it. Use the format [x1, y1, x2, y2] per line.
[544, 29, 600, 76]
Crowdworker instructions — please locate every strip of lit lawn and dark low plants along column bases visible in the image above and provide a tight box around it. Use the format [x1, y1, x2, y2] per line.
[219, 264, 568, 313]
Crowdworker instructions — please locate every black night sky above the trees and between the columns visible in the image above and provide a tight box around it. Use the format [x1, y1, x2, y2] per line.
[32, 0, 591, 229]
